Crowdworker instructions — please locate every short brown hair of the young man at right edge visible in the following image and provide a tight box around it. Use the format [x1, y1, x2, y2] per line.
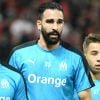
[83, 33, 100, 52]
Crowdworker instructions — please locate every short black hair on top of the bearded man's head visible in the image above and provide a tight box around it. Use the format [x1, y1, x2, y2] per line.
[38, 2, 64, 19]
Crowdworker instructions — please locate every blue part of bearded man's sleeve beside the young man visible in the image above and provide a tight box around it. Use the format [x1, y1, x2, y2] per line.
[74, 56, 92, 92]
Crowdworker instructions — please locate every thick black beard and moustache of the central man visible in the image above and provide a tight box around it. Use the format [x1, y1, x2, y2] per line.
[41, 29, 61, 45]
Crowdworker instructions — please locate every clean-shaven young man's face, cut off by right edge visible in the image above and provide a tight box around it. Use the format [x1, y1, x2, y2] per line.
[85, 43, 100, 73]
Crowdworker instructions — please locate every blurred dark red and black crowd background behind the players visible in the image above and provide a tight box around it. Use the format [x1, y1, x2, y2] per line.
[0, 0, 100, 62]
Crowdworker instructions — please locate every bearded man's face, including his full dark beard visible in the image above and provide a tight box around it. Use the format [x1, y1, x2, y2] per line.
[39, 9, 64, 44]
